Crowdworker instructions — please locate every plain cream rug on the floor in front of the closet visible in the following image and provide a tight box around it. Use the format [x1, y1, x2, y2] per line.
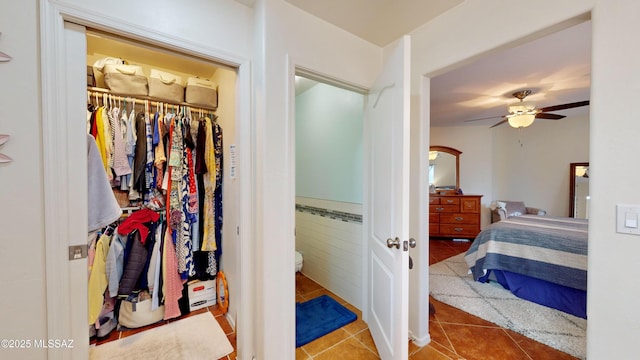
[89, 312, 233, 360]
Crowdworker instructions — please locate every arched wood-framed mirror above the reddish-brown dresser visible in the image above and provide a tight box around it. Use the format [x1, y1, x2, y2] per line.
[429, 146, 462, 192]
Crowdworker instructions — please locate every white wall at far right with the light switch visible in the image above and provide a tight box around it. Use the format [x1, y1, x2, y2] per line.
[587, 0, 640, 359]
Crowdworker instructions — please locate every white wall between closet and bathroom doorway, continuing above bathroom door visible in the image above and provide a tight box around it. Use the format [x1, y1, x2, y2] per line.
[254, 0, 381, 359]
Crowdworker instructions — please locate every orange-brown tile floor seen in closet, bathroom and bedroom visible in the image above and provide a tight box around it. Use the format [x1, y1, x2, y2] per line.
[91, 240, 575, 360]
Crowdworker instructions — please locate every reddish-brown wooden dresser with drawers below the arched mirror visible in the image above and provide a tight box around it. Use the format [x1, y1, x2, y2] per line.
[429, 194, 482, 239]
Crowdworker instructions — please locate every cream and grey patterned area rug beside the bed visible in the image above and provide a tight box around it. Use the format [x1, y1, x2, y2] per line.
[429, 253, 587, 359]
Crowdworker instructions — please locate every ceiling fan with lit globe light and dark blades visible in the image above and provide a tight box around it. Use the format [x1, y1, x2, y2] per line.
[465, 89, 589, 128]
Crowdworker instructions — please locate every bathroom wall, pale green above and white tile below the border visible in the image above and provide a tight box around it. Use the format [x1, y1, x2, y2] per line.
[295, 71, 365, 309]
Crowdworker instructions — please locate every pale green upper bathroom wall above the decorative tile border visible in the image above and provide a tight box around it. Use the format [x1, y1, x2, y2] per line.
[295, 83, 364, 204]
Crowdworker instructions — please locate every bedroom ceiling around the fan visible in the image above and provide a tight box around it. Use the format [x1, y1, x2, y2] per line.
[431, 21, 591, 126]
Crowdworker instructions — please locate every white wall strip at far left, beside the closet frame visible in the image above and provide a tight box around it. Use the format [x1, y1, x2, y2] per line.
[0, 0, 47, 359]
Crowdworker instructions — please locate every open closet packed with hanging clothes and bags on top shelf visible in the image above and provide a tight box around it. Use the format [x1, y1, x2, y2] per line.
[85, 29, 240, 359]
